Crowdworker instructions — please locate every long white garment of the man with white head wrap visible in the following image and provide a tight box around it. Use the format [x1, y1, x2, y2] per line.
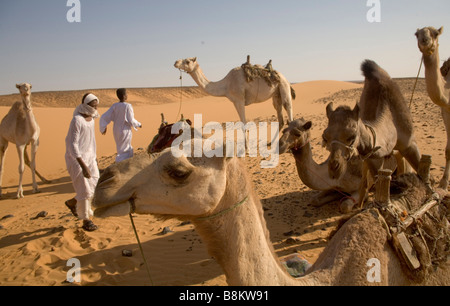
[65, 114, 100, 220]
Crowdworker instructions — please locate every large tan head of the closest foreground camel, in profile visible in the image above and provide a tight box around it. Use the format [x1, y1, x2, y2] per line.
[93, 140, 231, 219]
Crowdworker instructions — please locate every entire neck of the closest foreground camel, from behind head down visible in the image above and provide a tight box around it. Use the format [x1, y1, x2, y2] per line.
[192, 159, 318, 286]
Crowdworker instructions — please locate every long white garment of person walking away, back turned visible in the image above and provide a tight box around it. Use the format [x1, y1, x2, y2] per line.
[100, 102, 141, 162]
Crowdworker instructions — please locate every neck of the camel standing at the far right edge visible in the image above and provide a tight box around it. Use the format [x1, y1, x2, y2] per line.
[423, 47, 449, 107]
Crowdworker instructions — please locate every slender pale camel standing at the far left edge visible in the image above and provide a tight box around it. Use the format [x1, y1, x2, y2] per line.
[0, 83, 49, 199]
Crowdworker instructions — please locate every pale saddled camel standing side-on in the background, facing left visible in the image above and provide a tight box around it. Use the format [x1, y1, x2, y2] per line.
[175, 57, 295, 127]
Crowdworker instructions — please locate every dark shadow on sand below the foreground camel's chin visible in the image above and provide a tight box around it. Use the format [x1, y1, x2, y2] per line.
[47, 228, 223, 286]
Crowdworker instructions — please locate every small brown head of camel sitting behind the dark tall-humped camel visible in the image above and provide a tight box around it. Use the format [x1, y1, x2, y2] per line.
[280, 118, 312, 154]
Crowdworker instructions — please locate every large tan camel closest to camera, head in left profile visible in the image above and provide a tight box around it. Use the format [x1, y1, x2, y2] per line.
[93, 140, 450, 286]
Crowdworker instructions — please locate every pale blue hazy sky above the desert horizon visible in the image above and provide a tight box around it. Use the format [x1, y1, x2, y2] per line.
[0, 0, 450, 95]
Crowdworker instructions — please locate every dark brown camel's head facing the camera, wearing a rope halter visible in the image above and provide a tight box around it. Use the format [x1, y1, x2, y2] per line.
[322, 103, 359, 179]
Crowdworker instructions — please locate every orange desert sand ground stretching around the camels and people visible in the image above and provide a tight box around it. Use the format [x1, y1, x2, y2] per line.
[0, 79, 446, 286]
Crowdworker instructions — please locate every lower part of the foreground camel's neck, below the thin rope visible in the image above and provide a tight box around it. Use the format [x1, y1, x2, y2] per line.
[193, 196, 316, 286]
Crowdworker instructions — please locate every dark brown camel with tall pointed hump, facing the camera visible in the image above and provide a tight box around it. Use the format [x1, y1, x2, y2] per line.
[323, 60, 420, 205]
